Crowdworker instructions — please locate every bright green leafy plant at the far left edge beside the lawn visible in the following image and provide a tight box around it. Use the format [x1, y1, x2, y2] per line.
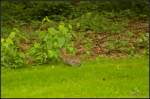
[1, 31, 24, 67]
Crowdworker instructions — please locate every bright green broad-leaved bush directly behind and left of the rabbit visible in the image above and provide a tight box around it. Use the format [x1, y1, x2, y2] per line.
[28, 23, 75, 64]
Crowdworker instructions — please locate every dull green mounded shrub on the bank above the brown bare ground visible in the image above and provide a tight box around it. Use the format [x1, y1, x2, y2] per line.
[72, 12, 127, 33]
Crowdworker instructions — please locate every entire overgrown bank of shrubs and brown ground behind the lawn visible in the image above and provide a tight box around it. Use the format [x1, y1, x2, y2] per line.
[1, 0, 148, 67]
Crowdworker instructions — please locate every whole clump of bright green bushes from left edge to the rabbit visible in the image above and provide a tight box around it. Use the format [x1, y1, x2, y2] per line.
[1, 18, 75, 67]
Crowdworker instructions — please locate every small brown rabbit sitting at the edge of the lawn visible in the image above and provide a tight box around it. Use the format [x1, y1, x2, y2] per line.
[60, 50, 81, 67]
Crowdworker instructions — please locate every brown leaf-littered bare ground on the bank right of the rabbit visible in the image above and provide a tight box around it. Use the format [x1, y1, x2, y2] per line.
[84, 20, 149, 57]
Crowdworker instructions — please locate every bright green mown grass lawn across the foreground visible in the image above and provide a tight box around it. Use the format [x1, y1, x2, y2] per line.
[1, 56, 149, 98]
